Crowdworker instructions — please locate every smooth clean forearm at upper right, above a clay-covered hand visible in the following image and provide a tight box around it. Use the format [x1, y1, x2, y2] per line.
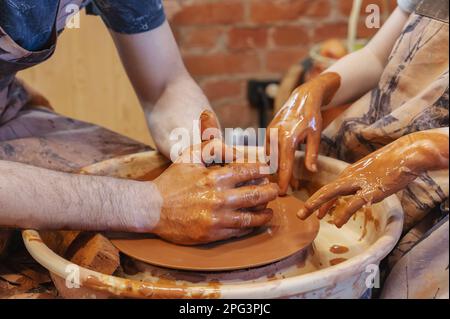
[325, 8, 409, 107]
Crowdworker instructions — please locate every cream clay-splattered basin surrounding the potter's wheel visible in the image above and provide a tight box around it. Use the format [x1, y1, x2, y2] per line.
[23, 152, 403, 298]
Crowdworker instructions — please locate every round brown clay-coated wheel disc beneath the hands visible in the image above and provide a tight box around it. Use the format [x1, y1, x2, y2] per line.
[112, 196, 319, 271]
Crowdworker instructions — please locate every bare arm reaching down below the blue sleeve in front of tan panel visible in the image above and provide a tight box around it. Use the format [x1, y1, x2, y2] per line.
[112, 22, 211, 157]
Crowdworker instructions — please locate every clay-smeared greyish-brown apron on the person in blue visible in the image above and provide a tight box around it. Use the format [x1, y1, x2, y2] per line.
[0, 0, 149, 172]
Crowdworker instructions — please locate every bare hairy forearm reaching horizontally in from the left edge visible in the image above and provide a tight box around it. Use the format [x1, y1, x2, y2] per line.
[0, 160, 161, 232]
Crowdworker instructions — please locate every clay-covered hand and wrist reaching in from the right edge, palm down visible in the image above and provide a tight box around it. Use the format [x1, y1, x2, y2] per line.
[298, 129, 449, 227]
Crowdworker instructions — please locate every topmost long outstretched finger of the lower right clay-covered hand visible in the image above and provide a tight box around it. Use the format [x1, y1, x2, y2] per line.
[297, 178, 359, 219]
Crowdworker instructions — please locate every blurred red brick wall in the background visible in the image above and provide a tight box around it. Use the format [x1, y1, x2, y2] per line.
[165, 0, 395, 127]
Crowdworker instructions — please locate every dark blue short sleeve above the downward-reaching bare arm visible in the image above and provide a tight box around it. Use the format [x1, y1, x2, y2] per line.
[92, 0, 166, 34]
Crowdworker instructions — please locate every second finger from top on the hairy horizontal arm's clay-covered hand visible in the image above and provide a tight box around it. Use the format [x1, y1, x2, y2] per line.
[223, 183, 278, 209]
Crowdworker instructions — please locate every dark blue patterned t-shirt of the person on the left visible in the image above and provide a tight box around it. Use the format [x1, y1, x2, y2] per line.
[0, 0, 166, 51]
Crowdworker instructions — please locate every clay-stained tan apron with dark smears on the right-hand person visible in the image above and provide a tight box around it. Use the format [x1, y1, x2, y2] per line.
[321, 0, 449, 298]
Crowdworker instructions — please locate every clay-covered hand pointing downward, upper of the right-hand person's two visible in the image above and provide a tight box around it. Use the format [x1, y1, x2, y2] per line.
[266, 72, 340, 195]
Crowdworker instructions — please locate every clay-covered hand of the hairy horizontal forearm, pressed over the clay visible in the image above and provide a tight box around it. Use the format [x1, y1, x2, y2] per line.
[153, 140, 278, 245]
